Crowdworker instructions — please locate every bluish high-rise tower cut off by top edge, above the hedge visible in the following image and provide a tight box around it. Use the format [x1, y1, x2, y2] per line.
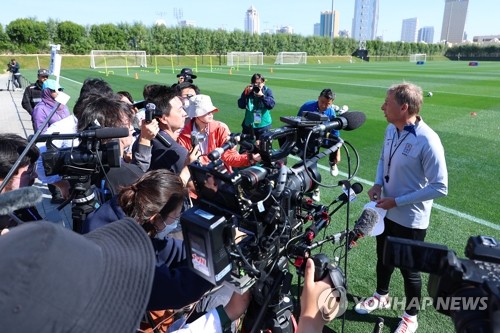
[352, 0, 378, 41]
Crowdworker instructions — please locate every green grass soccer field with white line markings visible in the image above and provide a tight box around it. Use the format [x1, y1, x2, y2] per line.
[43, 62, 500, 333]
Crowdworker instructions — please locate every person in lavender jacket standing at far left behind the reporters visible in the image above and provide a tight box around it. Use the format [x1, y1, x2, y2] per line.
[32, 79, 70, 134]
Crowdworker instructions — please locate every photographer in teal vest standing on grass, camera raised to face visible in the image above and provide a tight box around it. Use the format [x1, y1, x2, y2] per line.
[238, 73, 275, 140]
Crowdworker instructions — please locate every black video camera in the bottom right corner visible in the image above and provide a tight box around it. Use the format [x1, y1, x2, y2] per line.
[383, 236, 500, 333]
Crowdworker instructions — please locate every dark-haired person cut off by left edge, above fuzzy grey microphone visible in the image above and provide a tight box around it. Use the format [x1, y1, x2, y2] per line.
[0, 133, 42, 230]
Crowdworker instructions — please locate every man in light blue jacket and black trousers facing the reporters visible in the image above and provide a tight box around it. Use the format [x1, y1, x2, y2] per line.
[355, 83, 448, 333]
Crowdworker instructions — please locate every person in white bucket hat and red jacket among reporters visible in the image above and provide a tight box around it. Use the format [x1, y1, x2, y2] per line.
[177, 95, 260, 172]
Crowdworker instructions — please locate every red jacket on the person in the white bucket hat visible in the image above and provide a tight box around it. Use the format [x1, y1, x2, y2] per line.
[177, 119, 250, 172]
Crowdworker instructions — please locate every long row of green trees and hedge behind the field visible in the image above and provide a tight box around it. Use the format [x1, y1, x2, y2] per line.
[0, 18, 499, 57]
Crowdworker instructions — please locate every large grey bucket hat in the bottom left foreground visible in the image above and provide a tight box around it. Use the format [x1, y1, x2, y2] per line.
[0, 218, 155, 333]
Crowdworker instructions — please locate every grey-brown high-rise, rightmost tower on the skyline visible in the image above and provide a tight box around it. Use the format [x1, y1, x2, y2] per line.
[441, 0, 469, 43]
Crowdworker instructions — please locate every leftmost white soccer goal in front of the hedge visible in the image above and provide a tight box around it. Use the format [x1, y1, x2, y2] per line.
[90, 50, 147, 68]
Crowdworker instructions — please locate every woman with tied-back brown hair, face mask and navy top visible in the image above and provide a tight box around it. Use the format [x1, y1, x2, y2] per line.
[83, 169, 212, 310]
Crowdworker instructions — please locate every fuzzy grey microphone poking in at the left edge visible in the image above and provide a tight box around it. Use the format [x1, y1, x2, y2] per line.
[0, 186, 42, 215]
